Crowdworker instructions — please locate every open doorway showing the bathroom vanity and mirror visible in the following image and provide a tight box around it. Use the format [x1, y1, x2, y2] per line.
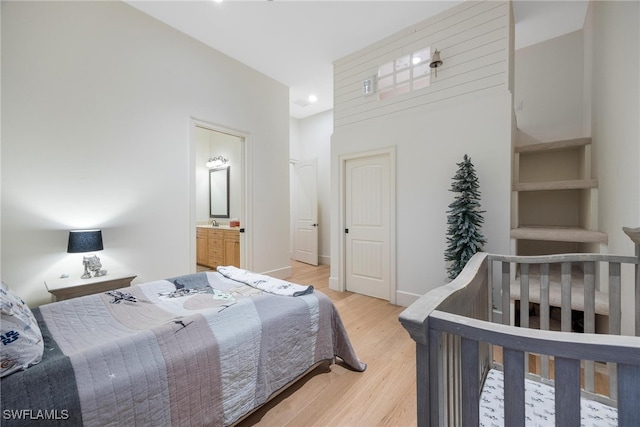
[190, 121, 250, 271]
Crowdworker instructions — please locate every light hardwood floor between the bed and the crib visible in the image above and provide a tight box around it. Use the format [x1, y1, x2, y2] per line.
[238, 262, 417, 427]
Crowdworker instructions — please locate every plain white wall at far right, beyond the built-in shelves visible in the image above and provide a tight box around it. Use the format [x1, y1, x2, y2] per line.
[585, 1, 640, 334]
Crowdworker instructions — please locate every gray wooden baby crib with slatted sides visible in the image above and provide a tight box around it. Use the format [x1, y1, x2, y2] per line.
[400, 228, 640, 427]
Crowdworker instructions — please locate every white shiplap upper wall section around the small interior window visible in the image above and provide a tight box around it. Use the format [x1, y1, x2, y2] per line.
[334, 1, 512, 128]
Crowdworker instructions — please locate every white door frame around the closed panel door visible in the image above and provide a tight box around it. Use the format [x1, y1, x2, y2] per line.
[338, 146, 397, 304]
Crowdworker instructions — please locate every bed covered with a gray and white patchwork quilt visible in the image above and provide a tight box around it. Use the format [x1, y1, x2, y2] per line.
[1, 270, 365, 426]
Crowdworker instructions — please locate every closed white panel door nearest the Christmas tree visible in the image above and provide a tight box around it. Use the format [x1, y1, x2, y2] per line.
[344, 154, 391, 300]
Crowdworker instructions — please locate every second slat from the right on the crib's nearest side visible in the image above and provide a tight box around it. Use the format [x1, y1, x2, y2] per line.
[555, 357, 580, 427]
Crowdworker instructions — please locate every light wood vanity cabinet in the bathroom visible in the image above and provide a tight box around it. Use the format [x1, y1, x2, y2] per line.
[196, 227, 240, 268]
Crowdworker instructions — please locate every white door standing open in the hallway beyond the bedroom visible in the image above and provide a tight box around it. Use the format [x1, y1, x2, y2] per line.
[293, 159, 318, 265]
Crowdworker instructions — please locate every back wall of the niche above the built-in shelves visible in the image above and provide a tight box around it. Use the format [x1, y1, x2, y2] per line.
[514, 31, 589, 143]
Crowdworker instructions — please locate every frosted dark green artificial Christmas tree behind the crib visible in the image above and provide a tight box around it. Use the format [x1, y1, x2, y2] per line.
[444, 154, 487, 279]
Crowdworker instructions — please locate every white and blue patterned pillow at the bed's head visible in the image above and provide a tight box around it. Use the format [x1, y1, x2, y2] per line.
[0, 283, 44, 377]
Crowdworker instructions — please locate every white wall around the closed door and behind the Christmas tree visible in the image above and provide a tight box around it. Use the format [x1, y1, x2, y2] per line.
[330, 1, 513, 305]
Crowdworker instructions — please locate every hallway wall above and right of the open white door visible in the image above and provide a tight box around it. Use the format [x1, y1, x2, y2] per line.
[291, 110, 333, 264]
